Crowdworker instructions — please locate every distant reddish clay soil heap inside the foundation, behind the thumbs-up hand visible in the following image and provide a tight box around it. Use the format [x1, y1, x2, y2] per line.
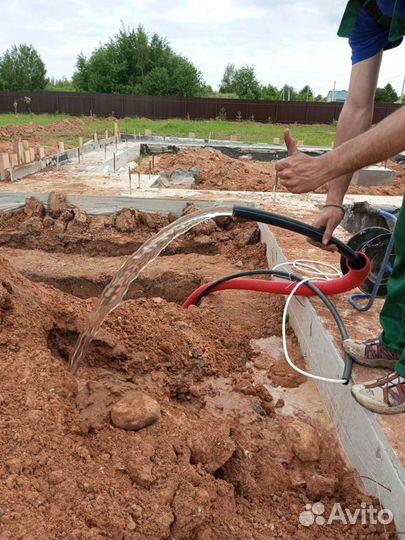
[139, 148, 404, 195]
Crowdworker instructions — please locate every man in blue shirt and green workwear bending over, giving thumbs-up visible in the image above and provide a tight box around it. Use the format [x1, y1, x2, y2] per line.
[276, 0, 405, 414]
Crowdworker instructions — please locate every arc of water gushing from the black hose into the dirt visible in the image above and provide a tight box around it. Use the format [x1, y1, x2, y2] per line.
[69, 207, 233, 373]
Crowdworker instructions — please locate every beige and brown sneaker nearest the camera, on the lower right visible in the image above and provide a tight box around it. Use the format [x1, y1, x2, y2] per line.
[352, 371, 405, 414]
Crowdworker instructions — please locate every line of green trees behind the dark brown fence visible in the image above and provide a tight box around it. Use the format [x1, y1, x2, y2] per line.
[0, 26, 399, 102]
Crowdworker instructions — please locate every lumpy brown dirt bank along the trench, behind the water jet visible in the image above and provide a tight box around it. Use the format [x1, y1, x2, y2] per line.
[0, 197, 266, 268]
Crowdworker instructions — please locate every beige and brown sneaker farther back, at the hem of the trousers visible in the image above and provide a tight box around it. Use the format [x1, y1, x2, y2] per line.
[343, 338, 401, 370]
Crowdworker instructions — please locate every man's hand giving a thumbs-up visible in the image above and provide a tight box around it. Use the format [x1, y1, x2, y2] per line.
[276, 130, 333, 193]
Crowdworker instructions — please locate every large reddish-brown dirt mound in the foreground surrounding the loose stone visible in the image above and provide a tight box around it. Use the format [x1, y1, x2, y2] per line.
[0, 259, 392, 540]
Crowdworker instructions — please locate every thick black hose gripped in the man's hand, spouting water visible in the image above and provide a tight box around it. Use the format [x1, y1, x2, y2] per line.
[233, 206, 364, 270]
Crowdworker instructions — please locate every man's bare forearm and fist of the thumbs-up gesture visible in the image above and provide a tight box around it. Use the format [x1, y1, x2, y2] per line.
[276, 107, 405, 193]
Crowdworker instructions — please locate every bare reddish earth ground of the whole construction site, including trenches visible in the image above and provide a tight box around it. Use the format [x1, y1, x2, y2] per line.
[0, 133, 405, 540]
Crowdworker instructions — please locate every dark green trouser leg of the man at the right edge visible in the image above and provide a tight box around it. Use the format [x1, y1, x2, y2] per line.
[380, 197, 405, 377]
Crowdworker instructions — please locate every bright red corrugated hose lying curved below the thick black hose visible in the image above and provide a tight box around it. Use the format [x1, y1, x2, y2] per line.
[183, 252, 370, 309]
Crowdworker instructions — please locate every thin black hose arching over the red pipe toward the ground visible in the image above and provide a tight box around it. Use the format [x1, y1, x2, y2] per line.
[195, 270, 353, 384]
